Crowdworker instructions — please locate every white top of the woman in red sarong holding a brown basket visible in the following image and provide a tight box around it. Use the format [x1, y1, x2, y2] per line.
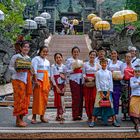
[83, 61, 98, 77]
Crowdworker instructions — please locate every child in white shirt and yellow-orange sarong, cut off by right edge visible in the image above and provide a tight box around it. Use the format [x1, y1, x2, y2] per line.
[129, 65, 140, 132]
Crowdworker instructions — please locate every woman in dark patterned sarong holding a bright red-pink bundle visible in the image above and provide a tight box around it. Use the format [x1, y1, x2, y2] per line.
[121, 53, 134, 120]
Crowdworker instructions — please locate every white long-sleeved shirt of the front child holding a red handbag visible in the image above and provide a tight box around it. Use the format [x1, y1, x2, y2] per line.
[96, 69, 113, 92]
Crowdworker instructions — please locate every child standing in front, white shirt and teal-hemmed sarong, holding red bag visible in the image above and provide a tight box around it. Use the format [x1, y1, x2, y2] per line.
[89, 58, 120, 127]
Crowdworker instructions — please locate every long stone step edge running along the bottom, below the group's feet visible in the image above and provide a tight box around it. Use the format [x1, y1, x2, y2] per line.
[0, 124, 140, 140]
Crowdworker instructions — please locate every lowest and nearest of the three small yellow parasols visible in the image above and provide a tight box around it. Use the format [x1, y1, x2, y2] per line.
[94, 21, 110, 31]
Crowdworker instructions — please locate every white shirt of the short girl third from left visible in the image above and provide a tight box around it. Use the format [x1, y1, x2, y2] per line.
[51, 64, 66, 85]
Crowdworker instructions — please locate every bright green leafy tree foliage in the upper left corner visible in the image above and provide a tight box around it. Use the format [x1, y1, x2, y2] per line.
[0, 0, 25, 43]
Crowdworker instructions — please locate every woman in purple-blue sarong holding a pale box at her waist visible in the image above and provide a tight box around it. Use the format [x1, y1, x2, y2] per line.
[108, 50, 123, 115]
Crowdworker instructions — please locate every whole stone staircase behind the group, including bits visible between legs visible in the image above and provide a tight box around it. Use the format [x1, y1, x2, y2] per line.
[0, 35, 89, 108]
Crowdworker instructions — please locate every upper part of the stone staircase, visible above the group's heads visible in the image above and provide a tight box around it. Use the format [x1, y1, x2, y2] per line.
[48, 35, 89, 63]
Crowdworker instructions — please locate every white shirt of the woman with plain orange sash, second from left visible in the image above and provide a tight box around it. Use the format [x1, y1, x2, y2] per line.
[32, 56, 50, 80]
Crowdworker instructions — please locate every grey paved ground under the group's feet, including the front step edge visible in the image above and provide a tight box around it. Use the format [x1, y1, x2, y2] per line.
[0, 106, 140, 138]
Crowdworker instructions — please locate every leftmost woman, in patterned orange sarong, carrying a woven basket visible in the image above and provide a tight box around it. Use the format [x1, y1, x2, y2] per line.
[9, 41, 32, 127]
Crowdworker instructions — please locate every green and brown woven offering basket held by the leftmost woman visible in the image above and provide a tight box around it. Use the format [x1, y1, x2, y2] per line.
[15, 57, 31, 70]
